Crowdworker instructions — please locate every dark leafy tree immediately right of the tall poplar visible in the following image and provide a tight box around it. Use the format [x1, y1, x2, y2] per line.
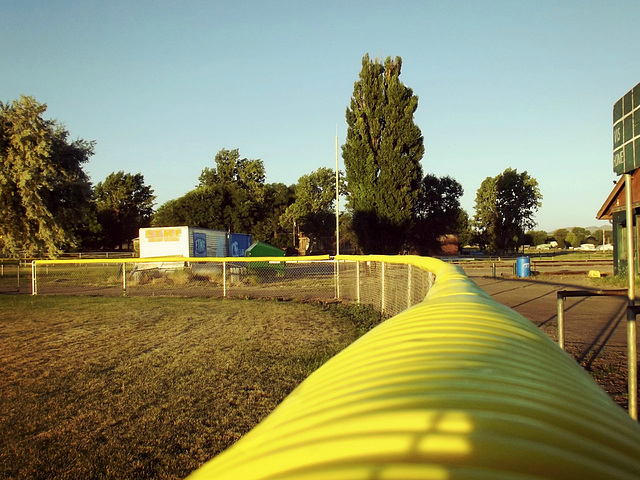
[414, 174, 464, 254]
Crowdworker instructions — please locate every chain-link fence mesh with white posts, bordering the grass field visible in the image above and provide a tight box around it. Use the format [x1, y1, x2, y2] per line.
[31, 256, 434, 315]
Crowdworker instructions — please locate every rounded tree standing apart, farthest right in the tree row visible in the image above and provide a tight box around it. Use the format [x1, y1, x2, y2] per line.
[474, 168, 542, 252]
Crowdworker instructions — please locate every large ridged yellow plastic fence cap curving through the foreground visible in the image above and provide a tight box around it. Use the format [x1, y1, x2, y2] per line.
[189, 256, 640, 480]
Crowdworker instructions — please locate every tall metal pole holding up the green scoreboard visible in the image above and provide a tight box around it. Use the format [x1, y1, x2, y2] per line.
[624, 173, 638, 420]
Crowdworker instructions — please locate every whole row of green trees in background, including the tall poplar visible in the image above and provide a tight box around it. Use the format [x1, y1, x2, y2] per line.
[0, 55, 542, 257]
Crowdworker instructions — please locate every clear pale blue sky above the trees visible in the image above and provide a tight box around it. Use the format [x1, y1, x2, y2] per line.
[0, 0, 640, 231]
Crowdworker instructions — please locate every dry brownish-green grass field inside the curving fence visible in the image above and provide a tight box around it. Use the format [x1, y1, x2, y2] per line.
[0, 296, 379, 479]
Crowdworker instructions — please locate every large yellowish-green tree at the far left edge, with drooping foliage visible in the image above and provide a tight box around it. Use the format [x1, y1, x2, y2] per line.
[0, 96, 94, 257]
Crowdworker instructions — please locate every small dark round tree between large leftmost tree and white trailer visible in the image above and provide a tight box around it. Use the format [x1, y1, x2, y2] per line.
[94, 171, 156, 248]
